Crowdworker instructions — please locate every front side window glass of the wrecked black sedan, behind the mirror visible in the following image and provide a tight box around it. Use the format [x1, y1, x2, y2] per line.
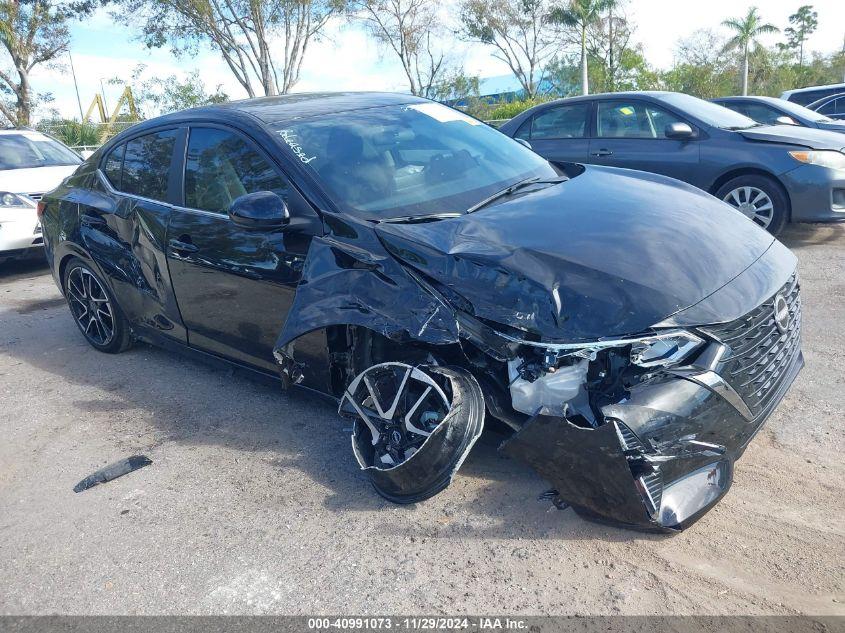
[185, 127, 288, 213]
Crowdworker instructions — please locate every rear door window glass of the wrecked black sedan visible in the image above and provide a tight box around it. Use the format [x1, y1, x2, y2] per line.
[120, 130, 179, 201]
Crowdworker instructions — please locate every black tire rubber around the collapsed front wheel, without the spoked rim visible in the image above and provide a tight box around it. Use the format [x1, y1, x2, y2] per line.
[340, 363, 484, 504]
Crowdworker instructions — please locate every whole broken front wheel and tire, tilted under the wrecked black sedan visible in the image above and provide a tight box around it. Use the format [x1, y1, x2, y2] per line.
[339, 363, 484, 503]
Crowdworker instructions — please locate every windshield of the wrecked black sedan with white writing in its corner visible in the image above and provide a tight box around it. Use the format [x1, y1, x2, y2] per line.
[273, 103, 557, 220]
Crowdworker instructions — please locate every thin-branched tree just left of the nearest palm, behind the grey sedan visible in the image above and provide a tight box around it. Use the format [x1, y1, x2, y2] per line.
[460, 0, 560, 99]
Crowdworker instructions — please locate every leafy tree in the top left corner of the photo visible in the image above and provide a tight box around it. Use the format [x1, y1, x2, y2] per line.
[0, 0, 94, 125]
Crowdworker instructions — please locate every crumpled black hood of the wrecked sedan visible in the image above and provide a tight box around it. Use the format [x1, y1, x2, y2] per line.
[375, 166, 774, 342]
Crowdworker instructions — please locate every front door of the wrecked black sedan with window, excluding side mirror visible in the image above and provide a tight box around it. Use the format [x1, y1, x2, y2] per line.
[167, 125, 321, 370]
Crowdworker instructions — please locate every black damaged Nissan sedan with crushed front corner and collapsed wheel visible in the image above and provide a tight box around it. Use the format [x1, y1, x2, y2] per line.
[39, 93, 803, 529]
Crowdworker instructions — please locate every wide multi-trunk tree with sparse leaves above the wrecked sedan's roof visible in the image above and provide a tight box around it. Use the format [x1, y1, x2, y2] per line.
[113, 0, 344, 97]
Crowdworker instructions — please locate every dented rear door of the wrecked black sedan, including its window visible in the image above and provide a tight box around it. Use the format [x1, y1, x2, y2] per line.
[76, 127, 186, 342]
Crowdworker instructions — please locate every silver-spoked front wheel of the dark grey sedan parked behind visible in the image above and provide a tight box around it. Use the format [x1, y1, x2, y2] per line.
[716, 174, 789, 235]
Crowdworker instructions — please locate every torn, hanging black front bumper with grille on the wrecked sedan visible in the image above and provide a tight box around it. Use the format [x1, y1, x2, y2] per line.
[501, 266, 804, 530]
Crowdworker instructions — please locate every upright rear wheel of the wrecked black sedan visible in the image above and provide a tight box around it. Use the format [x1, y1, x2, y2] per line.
[62, 258, 132, 354]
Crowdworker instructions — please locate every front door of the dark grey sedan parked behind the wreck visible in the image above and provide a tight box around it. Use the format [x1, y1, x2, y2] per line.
[588, 99, 704, 186]
